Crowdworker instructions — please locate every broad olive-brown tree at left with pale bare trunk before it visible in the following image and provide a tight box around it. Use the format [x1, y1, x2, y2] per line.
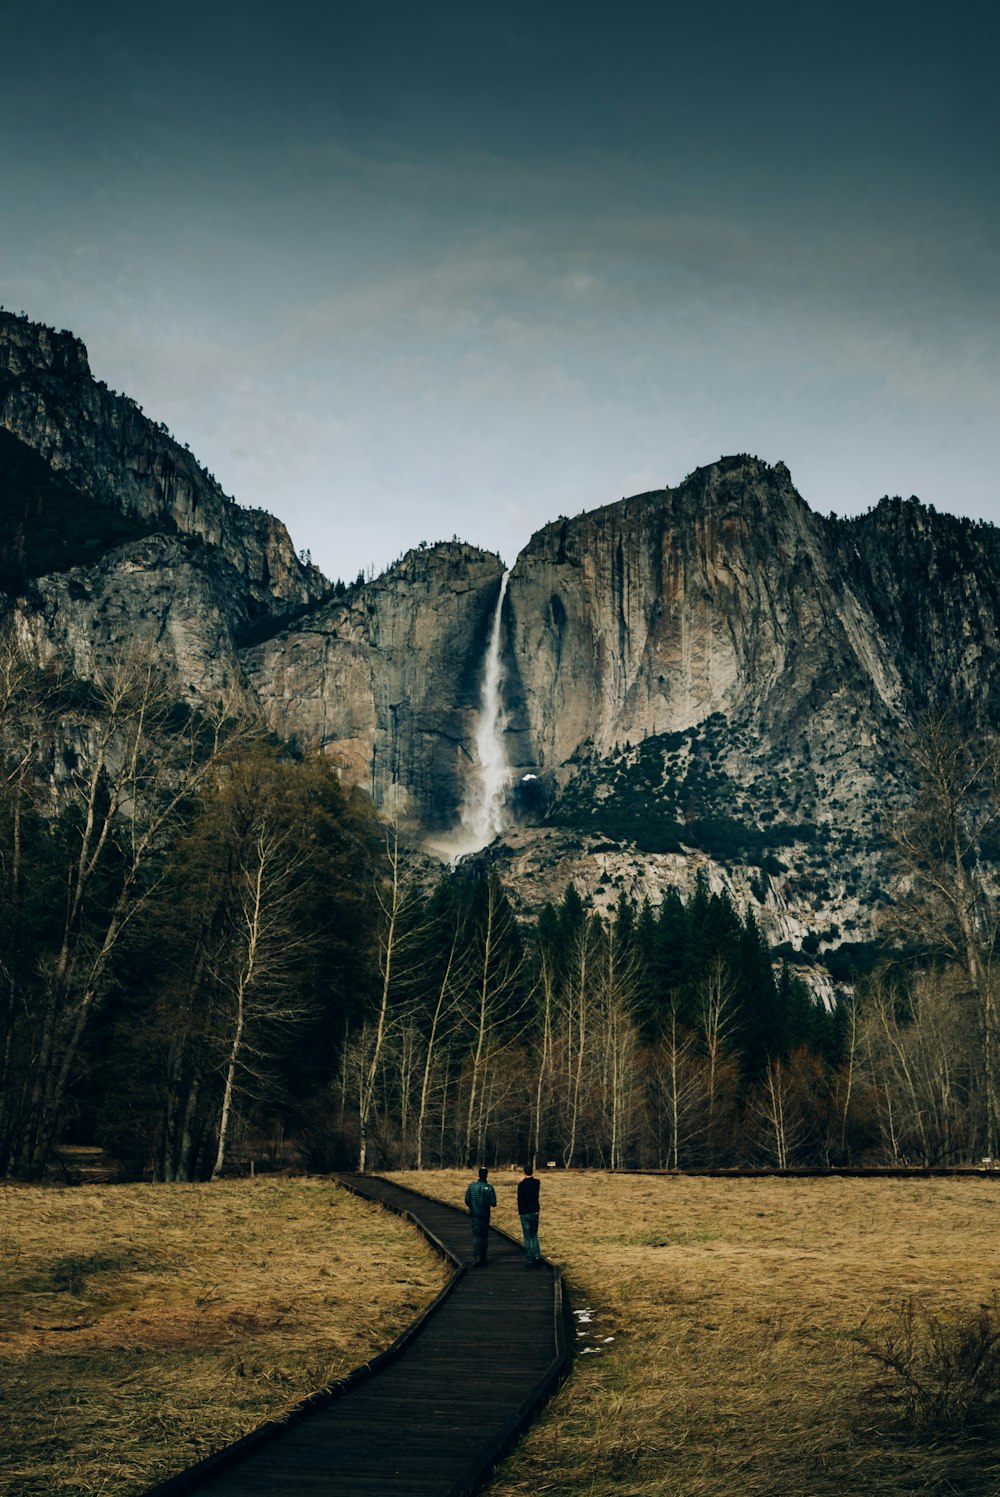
[103, 738, 383, 1180]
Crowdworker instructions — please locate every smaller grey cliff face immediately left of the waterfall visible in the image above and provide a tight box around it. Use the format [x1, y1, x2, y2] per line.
[243, 543, 503, 831]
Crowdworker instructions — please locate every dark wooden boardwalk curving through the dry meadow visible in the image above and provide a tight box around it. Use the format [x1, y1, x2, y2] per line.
[147, 1175, 569, 1497]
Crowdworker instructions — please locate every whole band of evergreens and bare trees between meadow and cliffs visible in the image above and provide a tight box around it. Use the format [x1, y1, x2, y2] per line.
[0, 635, 1000, 1181]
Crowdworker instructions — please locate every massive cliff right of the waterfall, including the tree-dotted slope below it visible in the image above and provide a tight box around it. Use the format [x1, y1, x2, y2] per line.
[479, 458, 930, 949]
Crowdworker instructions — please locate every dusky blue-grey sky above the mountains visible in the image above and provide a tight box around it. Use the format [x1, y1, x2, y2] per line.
[0, 0, 1000, 579]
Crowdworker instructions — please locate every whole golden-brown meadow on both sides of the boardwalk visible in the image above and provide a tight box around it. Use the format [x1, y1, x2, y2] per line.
[7, 1171, 1000, 1497]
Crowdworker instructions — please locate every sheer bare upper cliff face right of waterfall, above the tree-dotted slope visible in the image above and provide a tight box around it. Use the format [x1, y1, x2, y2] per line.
[509, 458, 901, 771]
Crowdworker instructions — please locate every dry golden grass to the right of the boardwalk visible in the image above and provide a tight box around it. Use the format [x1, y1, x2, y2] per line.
[394, 1171, 1000, 1497]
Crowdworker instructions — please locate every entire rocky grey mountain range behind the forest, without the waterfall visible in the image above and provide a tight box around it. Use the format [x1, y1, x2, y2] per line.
[0, 313, 1000, 967]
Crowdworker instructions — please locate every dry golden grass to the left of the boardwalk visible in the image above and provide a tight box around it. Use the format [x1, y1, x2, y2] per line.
[0, 1178, 445, 1497]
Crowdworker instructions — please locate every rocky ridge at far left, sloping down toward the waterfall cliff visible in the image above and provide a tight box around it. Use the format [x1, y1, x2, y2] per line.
[0, 313, 328, 696]
